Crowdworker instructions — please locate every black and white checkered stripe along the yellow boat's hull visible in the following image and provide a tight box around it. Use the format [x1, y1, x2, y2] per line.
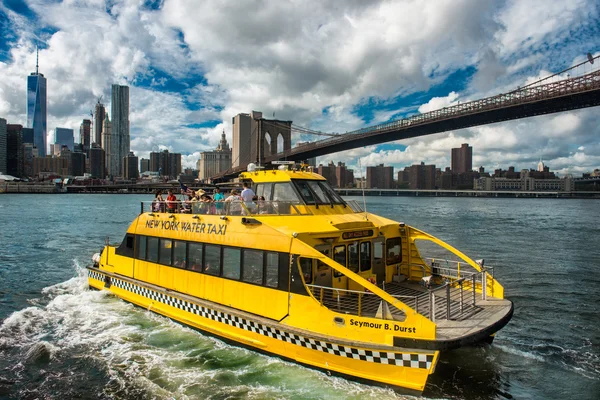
[88, 270, 433, 369]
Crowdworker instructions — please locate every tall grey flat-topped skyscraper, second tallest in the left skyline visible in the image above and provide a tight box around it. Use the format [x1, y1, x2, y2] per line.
[107, 85, 130, 176]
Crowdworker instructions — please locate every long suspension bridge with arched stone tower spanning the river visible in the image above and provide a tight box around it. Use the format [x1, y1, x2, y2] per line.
[213, 54, 600, 179]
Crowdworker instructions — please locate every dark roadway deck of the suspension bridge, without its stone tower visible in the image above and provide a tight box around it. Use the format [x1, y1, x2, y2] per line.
[215, 70, 600, 179]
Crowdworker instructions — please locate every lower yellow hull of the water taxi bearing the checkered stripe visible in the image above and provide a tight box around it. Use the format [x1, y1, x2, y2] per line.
[88, 267, 439, 392]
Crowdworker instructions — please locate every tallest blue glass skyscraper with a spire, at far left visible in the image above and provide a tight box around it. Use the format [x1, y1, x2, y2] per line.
[27, 48, 47, 157]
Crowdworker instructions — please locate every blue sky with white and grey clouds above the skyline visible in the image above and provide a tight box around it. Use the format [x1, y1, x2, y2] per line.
[0, 0, 600, 175]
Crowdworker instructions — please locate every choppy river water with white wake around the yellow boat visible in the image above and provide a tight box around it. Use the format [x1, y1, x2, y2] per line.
[0, 195, 600, 399]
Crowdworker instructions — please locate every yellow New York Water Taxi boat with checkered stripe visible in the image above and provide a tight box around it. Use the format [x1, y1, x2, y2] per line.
[88, 169, 513, 392]
